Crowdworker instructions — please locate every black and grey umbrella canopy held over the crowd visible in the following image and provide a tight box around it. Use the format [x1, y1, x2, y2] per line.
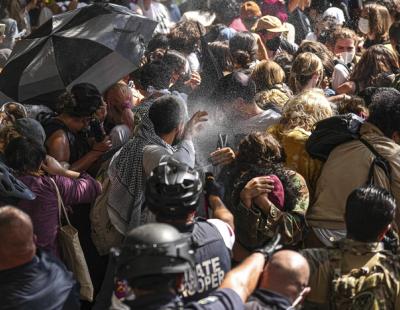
[0, 3, 157, 107]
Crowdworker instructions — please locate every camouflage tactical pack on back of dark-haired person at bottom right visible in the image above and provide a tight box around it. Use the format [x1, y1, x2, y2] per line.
[328, 249, 393, 310]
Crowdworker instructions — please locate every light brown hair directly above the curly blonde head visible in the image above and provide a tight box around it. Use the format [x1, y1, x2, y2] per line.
[289, 52, 324, 93]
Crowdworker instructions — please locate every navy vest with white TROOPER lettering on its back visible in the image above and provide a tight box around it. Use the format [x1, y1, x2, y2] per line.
[182, 218, 231, 303]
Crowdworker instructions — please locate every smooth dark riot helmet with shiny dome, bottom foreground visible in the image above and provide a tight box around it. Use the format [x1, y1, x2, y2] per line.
[116, 223, 195, 287]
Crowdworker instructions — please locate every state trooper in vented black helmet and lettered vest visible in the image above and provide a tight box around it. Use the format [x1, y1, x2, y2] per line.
[146, 160, 235, 302]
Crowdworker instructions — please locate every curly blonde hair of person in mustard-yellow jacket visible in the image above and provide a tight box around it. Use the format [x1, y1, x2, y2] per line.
[280, 89, 333, 131]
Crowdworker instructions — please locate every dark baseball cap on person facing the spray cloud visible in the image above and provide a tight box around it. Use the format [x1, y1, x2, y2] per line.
[212, 71, 257, 102]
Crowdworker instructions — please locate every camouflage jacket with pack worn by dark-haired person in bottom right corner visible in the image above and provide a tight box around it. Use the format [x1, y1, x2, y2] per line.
[302, 239, 400, 310]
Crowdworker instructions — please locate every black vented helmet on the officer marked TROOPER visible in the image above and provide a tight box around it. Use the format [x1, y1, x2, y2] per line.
[146, 160, 202, 219]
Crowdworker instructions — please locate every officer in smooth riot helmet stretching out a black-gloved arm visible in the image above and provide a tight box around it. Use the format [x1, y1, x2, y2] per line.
[116, 223, 280, 310]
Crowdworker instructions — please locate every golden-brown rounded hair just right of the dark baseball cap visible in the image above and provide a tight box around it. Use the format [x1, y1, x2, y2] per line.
[251, 60, 285, 91]
